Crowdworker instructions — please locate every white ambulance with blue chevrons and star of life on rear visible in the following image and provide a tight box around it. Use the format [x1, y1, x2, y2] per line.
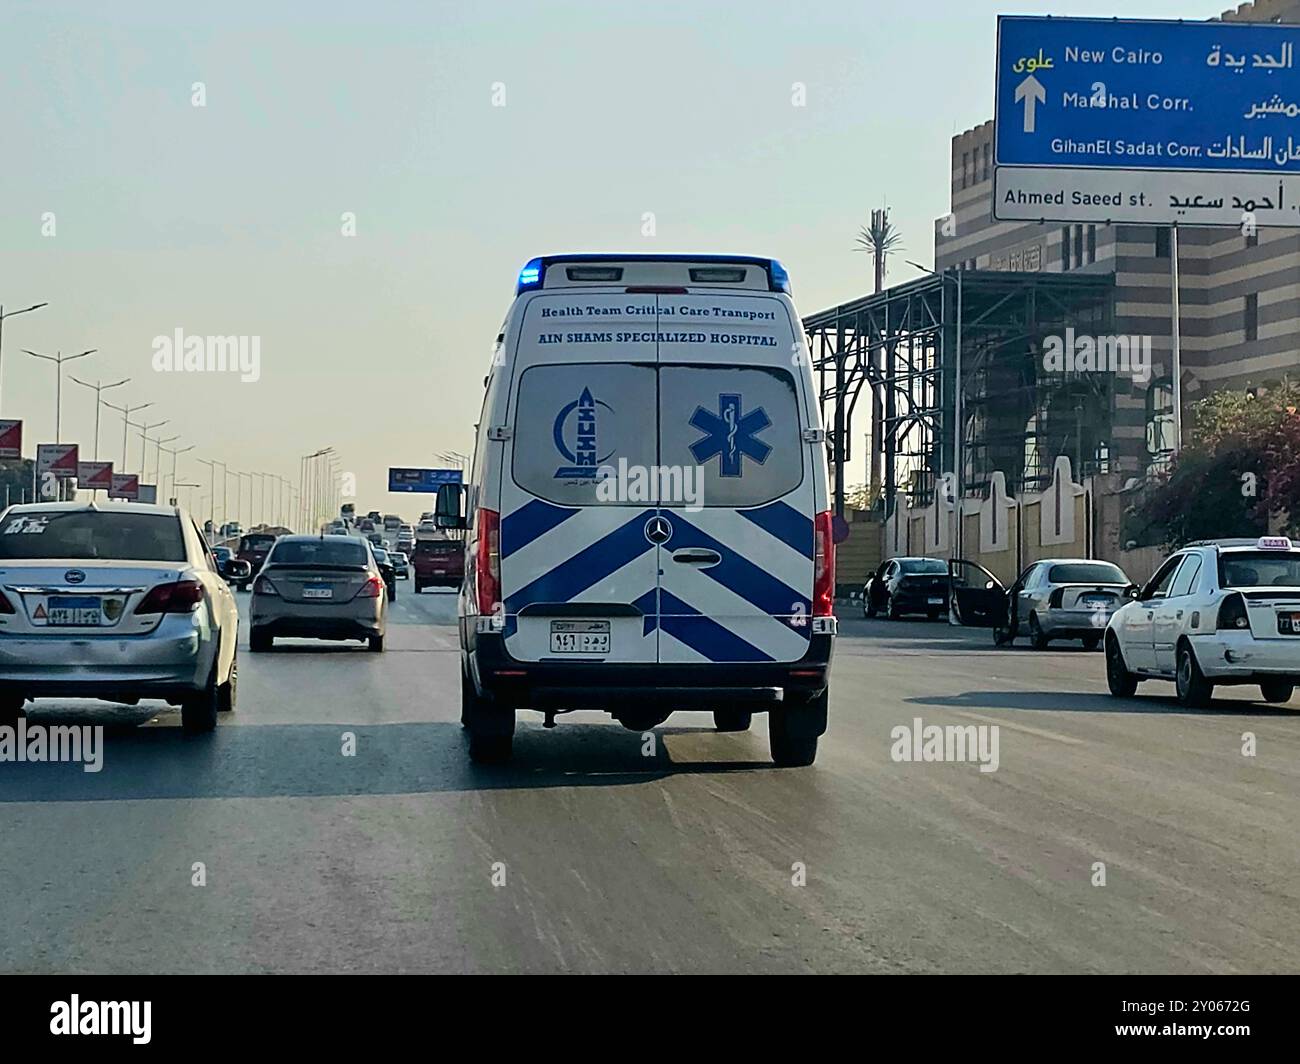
[437, 255, 836, 765]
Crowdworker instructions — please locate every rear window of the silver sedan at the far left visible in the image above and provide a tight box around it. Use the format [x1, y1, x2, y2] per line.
[0, 510, 186, 562]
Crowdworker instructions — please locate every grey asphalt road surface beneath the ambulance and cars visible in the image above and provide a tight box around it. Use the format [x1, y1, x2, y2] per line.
[0, 583, 1300, 973]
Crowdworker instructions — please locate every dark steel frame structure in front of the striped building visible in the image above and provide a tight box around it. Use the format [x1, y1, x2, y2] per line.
[803, 269, 1114, 514]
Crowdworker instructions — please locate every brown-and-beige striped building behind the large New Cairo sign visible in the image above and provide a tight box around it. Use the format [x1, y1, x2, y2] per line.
[935, 0, 1300, 475]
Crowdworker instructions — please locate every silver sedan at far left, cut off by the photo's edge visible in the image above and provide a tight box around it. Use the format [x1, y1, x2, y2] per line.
[0, 502, 239, 731]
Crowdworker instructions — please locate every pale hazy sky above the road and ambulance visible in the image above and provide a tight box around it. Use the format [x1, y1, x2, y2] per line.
[0, 0, 1206, 516]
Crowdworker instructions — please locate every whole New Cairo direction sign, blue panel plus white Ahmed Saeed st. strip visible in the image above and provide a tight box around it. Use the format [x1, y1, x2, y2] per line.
[993, 16, 1300, 226]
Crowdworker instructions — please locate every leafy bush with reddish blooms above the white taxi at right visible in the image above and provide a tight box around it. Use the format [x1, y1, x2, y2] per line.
[1132, 380, 1300, 546]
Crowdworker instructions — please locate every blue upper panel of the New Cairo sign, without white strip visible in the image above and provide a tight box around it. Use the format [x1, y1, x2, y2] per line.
[995, 16, 1300, 174]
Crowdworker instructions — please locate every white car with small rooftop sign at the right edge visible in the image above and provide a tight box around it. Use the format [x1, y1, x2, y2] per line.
[1106, 536, 1300, 706]
